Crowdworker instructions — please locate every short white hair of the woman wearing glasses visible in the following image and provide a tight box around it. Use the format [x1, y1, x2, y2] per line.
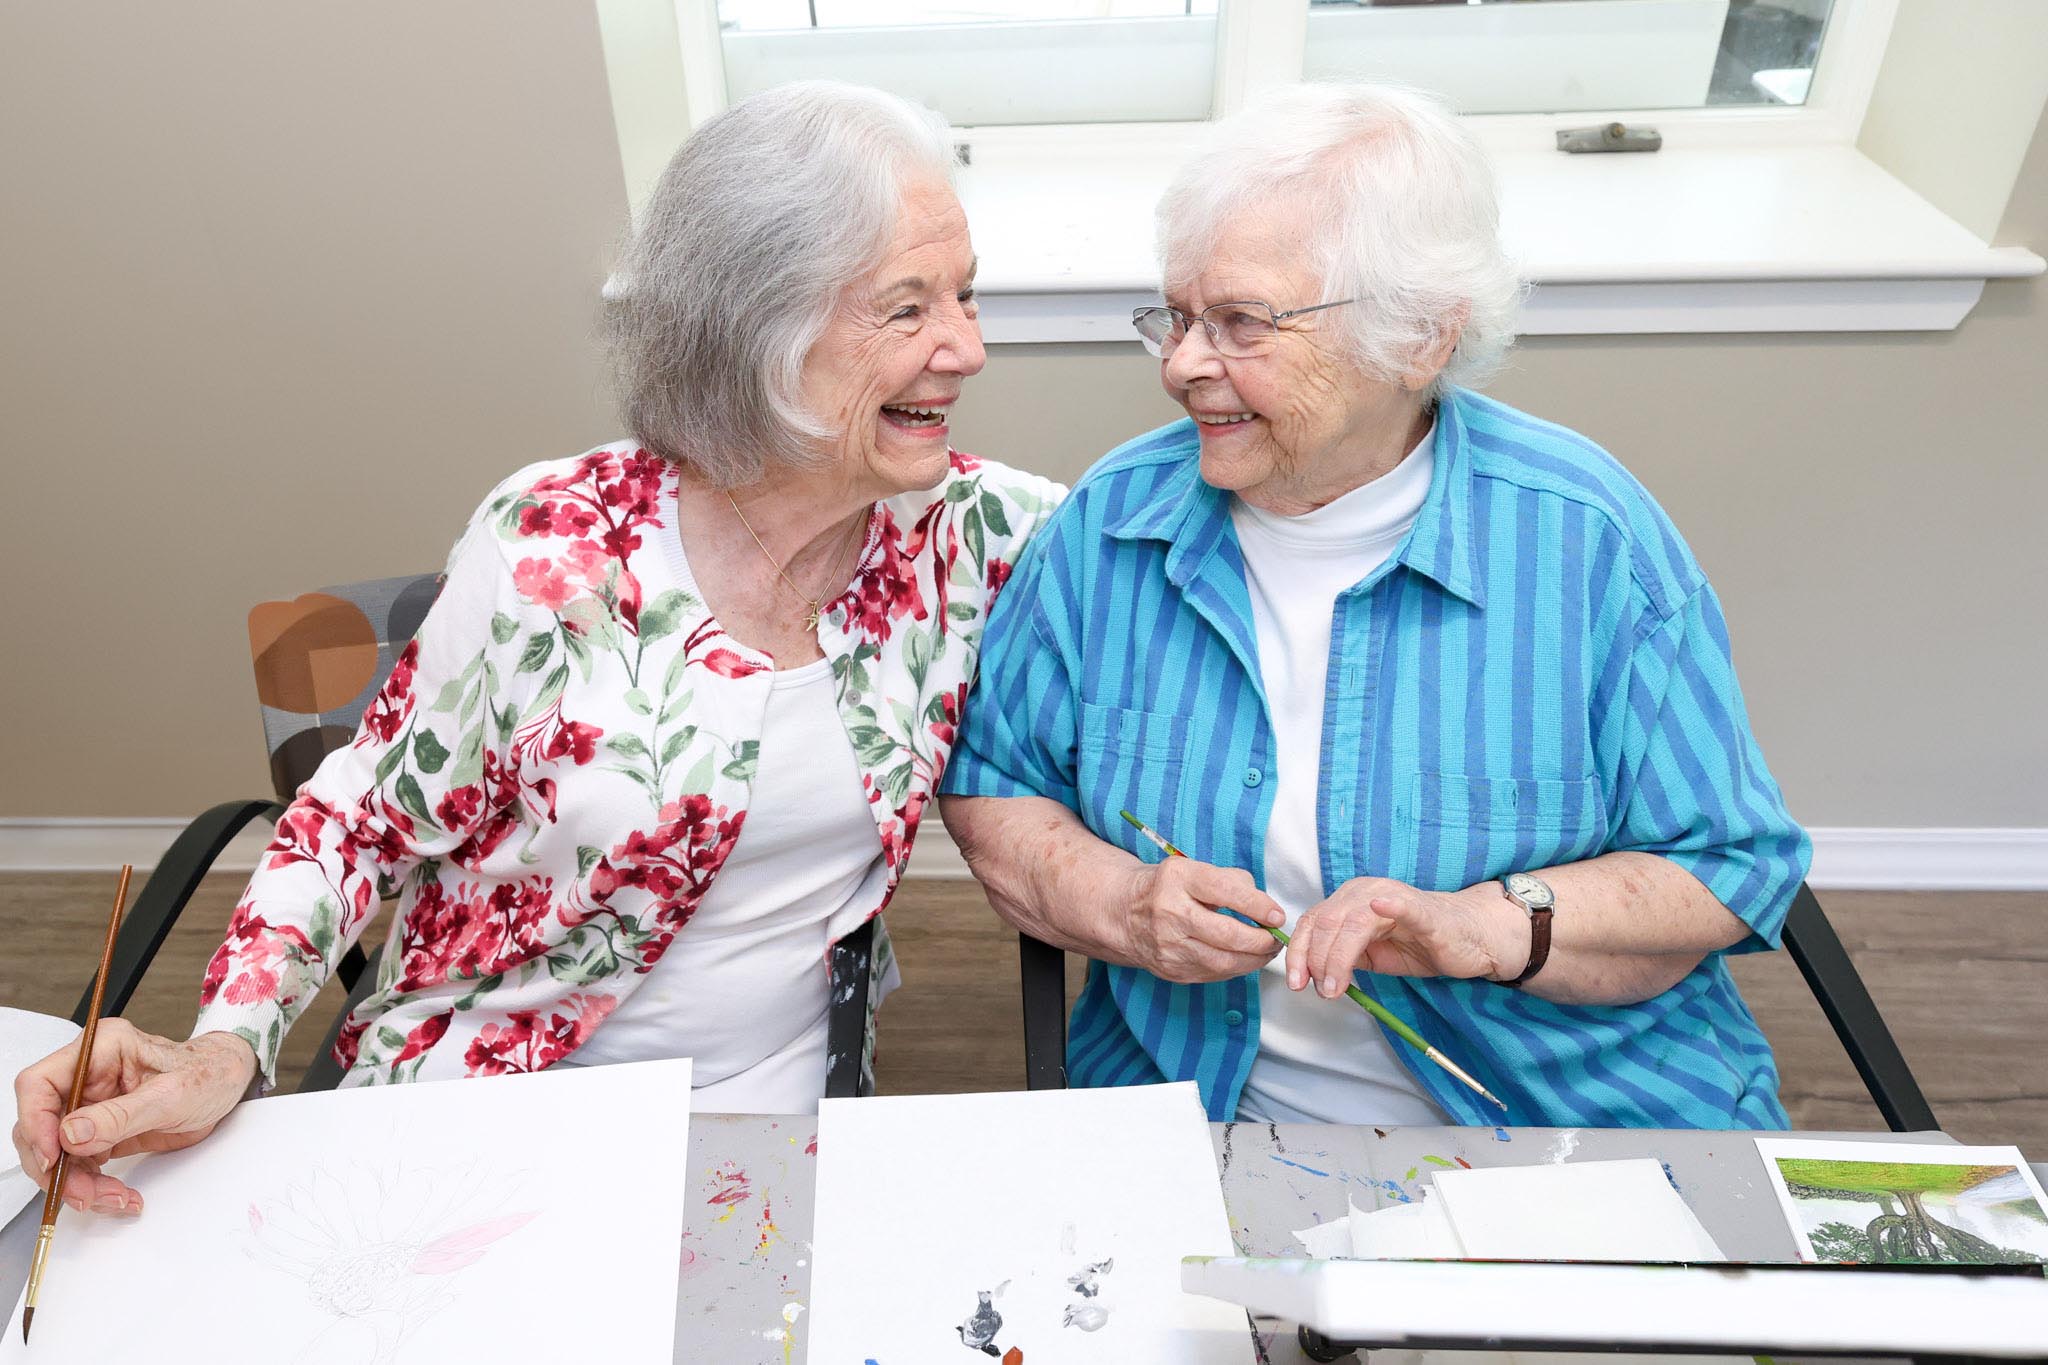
[1157, 84, 1524, 397]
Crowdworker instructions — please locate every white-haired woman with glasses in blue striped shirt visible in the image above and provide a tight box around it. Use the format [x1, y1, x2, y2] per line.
[944, 86, 1808, 1128]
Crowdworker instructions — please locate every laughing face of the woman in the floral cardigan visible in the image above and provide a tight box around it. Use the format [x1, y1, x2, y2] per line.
[803, 180, 985, 497]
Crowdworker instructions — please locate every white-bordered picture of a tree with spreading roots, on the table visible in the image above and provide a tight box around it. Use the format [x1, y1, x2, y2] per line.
[1757, 1138, 2048, 1265]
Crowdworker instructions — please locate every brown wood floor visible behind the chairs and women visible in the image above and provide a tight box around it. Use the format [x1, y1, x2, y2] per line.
[0, 872, 2048, 1160]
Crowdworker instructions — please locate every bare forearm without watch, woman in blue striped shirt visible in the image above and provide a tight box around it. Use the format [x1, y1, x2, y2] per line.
[938, 796, 1145, 966]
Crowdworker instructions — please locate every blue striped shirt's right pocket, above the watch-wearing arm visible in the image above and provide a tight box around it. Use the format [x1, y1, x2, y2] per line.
[1393, 772, 1608, 890]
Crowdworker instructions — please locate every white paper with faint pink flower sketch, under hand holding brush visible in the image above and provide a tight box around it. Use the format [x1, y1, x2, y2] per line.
[0, 1060, 690, 1365]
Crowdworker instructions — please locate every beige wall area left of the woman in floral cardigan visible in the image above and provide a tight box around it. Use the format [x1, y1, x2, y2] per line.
[0, 0, 625, 817]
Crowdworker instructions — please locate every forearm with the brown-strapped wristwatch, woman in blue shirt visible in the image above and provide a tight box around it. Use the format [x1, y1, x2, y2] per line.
[1462, 853, 1749, 1005]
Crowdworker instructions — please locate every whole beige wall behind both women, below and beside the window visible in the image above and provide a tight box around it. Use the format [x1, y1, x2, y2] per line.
[0, 0, 2048, 825]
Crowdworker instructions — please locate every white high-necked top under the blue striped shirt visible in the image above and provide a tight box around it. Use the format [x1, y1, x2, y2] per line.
[1231, 426, 1448, 1126]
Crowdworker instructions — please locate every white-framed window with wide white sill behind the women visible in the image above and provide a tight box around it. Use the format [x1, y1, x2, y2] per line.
[647, 0, 2048, 335]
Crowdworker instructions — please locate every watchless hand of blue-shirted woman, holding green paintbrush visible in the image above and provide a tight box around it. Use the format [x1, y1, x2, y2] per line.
[1106, 857, 1286, 982]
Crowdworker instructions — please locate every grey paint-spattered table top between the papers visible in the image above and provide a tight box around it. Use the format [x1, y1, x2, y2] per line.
[0, 1113, 2048, 1365]
